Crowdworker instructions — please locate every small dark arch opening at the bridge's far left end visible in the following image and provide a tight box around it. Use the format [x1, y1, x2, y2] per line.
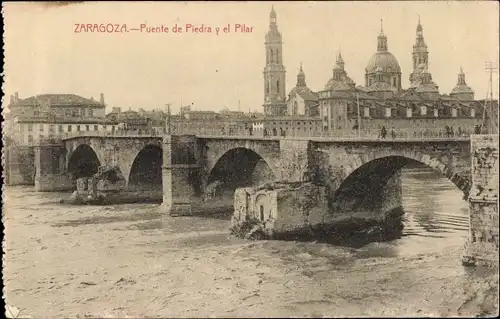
[67, 144, 101, 179]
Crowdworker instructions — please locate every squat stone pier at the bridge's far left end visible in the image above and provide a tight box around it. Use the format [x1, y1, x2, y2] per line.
[35, 144, 75, 192]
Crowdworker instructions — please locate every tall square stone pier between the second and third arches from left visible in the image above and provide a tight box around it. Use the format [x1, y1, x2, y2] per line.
[162, 135, 201, 216]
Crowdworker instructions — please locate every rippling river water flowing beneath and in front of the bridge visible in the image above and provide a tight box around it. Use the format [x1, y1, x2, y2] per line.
[4, 169, 496, 317]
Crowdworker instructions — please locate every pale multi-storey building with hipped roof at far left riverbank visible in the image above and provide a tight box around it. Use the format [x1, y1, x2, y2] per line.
[6, 93, 117, 145]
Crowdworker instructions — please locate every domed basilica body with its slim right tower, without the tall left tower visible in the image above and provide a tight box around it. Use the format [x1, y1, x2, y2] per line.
[319, 15, 484, 135]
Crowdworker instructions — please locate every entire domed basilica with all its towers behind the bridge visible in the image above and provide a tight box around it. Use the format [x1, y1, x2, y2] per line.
[263, 8, 484, 133]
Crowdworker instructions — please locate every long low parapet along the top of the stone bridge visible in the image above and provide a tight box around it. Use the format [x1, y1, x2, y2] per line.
[60, 128, 470, 140]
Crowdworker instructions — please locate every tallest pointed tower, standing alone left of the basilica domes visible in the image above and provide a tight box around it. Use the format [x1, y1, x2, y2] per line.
[264, 6, 286, 115]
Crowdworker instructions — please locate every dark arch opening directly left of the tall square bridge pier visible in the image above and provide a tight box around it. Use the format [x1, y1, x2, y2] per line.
[127, 144, 163, 188]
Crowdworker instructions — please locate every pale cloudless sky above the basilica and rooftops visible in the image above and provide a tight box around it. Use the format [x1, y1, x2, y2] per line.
[2, 1, 499, 112]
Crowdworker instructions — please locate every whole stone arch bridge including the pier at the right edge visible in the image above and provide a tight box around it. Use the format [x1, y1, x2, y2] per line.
[29, 134, 499, 264]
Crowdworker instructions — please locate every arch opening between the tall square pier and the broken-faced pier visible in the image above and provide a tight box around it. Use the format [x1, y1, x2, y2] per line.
[207, 147, 279, 189]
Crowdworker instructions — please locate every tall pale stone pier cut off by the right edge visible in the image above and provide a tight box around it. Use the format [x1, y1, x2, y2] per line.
[462, 134, 499, 266]
